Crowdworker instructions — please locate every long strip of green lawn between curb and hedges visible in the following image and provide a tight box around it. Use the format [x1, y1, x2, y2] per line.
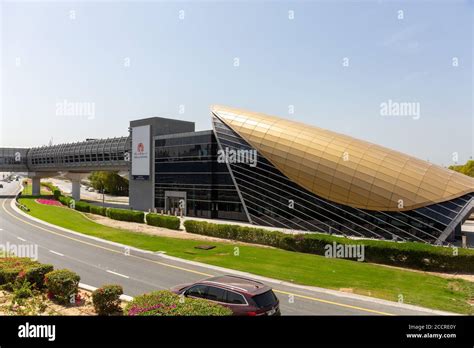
[16, 197, 474, 314]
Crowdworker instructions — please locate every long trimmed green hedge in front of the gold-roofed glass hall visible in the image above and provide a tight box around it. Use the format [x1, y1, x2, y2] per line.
[184, 220, 474, 273]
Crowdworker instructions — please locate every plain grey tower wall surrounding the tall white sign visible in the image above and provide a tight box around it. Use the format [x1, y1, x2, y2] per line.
[129, 117, 194, 211]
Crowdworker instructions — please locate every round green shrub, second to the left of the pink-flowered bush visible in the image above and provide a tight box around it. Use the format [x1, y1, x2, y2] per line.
[45, 269, 81, 304]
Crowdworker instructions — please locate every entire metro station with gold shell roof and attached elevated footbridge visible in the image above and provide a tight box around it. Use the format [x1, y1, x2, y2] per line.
[0, 106, 474, 244]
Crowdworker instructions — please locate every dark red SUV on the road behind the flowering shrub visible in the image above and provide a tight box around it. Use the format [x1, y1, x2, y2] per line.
[171, 275, 281, 316]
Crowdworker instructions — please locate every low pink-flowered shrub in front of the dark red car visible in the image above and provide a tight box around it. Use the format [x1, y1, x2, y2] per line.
[125, 290, 232, 316]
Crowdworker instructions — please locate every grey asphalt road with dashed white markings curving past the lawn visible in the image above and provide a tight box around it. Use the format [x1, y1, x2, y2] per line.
[0, 182, 436, 315]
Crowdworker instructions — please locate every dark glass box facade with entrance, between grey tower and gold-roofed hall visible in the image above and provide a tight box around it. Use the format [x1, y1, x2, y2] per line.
[155, 131, 247, 221]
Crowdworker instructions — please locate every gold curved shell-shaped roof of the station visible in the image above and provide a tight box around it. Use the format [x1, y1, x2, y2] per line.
[211, 106, 474, 211]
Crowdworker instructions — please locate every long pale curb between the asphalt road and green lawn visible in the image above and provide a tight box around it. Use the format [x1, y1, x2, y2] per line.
[10, 196, 460, 316]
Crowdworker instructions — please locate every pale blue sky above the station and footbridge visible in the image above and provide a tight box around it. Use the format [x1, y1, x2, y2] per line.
[0, 1, 474, 165]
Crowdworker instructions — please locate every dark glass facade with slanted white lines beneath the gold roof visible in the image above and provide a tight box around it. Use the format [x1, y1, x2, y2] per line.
[213, 116, 474, 243]
